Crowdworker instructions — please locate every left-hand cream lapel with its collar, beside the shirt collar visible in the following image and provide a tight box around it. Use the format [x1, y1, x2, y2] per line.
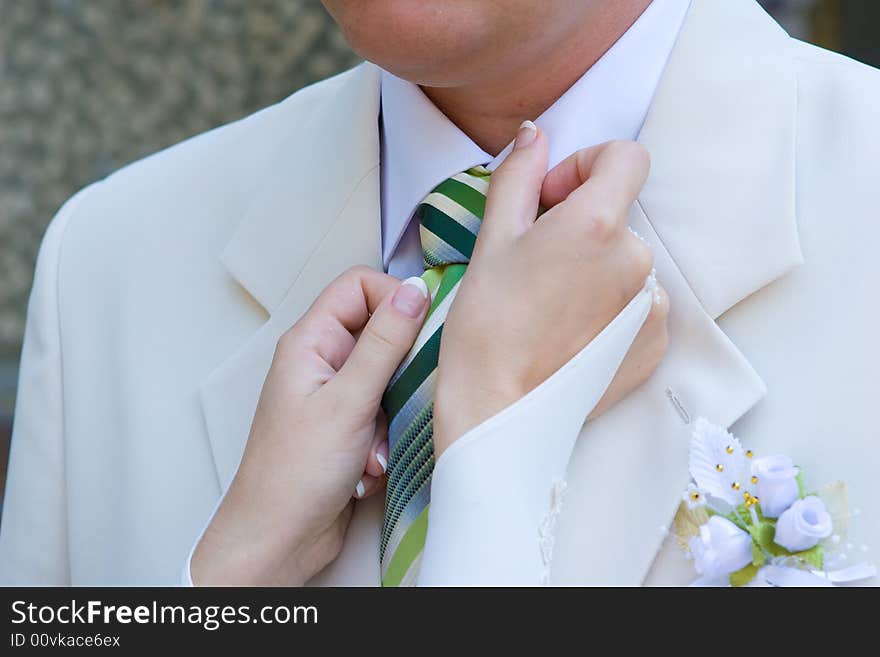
[200, 65, 381, 490]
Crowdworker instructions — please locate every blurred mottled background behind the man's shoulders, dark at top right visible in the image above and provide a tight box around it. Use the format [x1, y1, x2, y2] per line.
[0, 0, 880, 500]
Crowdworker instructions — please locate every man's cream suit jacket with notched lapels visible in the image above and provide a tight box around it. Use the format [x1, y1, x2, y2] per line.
[0, 0, 880, 585]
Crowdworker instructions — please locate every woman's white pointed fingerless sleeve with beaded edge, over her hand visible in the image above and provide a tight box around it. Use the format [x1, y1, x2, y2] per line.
[417, 282, 654, 586]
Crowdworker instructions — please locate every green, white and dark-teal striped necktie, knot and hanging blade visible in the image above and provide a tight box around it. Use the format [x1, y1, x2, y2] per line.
[380, 167, 491, 586]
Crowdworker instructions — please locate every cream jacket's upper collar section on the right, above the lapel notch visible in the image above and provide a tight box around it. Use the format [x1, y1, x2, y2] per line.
[639, 0, 802, 318]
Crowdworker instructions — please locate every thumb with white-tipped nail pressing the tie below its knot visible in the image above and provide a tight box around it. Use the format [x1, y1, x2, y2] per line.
[333, 276, 429, 404]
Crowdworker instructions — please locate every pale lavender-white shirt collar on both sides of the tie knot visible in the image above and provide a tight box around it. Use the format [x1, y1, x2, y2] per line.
[381, 0, 690, 267]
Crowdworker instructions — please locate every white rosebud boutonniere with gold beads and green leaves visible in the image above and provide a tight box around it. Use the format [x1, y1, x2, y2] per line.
[673, 418, 877, 586]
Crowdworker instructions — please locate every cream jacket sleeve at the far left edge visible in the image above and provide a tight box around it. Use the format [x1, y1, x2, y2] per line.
[0, 188, 94, 586]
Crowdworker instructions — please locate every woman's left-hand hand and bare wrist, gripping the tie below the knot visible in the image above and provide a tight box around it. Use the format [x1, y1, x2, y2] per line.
[191, 267, 428, 586]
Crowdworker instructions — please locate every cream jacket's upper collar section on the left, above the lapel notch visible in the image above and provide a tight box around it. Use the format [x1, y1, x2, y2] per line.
[221, 64, 380, 313]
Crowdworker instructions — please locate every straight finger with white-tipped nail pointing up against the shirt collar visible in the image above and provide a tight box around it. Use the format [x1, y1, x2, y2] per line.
[478, 121, 548, 241]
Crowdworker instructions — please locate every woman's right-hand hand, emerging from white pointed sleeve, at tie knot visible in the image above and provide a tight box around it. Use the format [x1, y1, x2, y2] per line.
[434, 125, 669, 457]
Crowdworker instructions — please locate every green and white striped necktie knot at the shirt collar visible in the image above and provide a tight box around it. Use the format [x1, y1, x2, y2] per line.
[416, 166, 491, 269]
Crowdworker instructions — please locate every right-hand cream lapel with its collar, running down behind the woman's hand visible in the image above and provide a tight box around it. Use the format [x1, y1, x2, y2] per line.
[553, 0, 802, 585]
